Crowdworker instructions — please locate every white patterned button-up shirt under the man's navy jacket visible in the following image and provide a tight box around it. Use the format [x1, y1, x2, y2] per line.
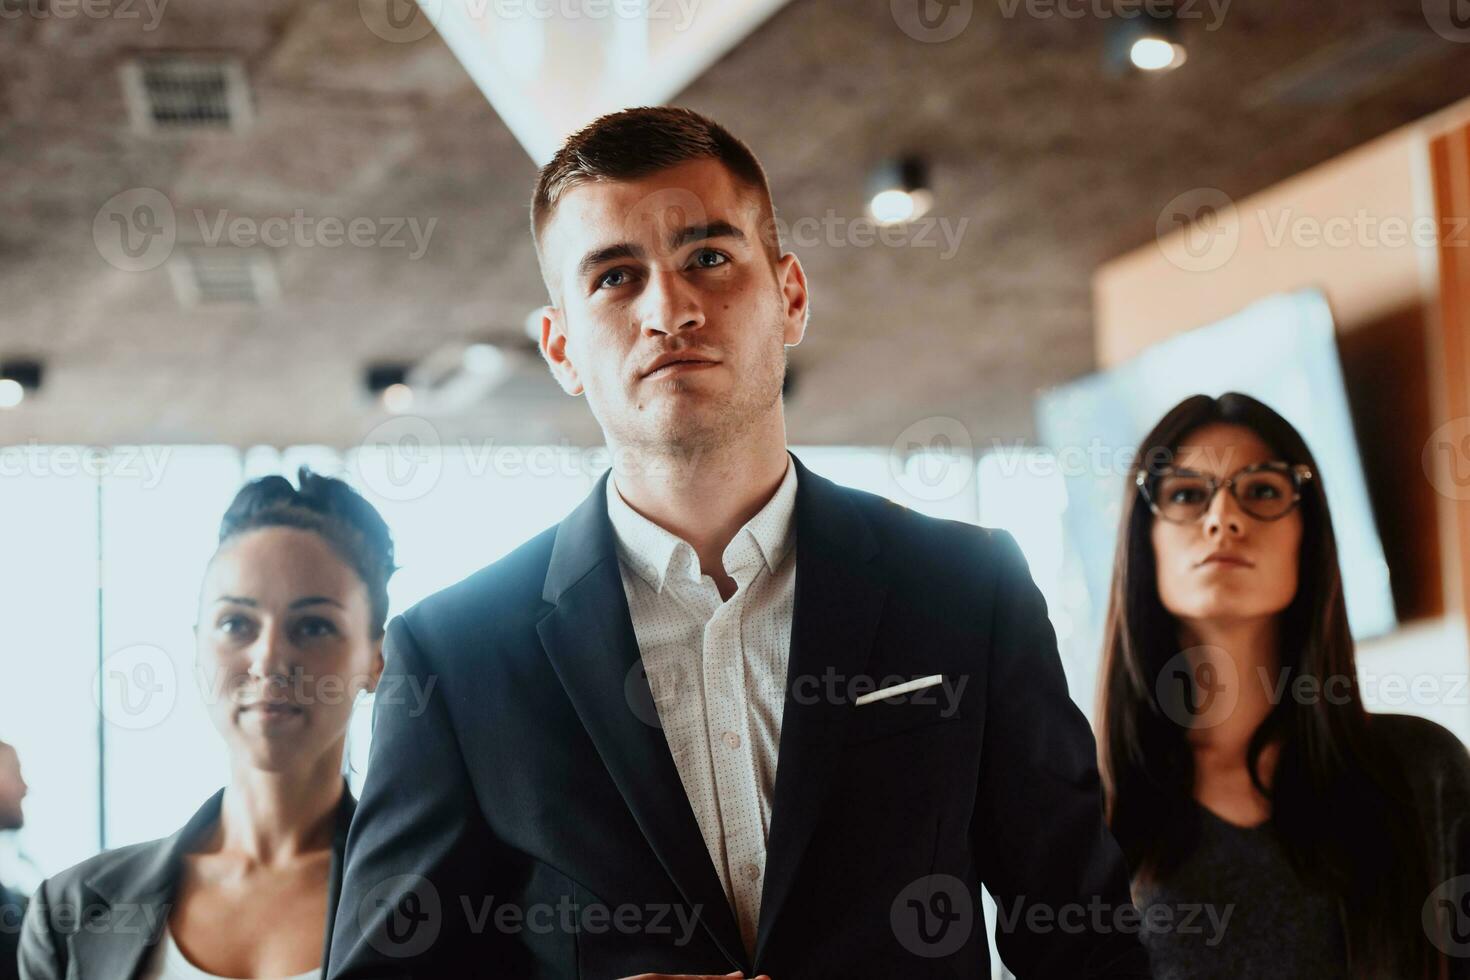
[607, 454, 797, 955]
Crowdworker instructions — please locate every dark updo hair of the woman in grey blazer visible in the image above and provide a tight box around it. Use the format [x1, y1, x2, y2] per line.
[219, 466, 397, 636]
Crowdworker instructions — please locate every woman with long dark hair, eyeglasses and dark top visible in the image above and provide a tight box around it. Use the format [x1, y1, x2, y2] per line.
[1098, 392, 1470, 980]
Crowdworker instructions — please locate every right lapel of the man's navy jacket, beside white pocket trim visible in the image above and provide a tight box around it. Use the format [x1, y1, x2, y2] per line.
[754, 455, 888, 971]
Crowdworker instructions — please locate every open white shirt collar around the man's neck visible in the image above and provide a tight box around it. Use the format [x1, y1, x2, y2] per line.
[607, 453, 797, 592]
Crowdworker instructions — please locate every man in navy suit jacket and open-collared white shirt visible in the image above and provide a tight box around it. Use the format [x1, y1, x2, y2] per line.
[328, 109, 1148, 980]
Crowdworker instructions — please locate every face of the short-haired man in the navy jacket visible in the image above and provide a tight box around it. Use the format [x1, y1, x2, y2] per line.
[541, 160, 807, 455]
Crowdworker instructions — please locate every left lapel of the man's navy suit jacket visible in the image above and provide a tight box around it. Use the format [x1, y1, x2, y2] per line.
[537, 473, 747, 968]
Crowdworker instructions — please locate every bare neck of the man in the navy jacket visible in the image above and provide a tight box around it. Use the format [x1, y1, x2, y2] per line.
[613, 417, 791, 582]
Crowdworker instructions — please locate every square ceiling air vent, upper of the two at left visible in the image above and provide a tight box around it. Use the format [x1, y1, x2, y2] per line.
[122, 54, 251, 134]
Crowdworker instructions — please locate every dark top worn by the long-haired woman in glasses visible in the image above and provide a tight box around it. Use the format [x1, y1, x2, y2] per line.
[1133, 714, 1470, 980]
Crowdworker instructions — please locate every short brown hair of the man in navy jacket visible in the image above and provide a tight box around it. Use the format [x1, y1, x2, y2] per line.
[531, 106, 781, 257]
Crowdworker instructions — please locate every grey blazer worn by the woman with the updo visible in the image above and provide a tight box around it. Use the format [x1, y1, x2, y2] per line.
[19, 788, 357, 980]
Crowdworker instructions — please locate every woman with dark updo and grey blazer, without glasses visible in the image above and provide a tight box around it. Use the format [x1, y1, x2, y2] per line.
[21, 467, 394, 980]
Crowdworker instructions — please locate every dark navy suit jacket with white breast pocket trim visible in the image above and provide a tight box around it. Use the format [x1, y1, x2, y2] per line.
[329, 461, 1150, 980]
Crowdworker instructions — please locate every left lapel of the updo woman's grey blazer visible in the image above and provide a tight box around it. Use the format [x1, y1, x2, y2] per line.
[72, 789, 225, 980]
